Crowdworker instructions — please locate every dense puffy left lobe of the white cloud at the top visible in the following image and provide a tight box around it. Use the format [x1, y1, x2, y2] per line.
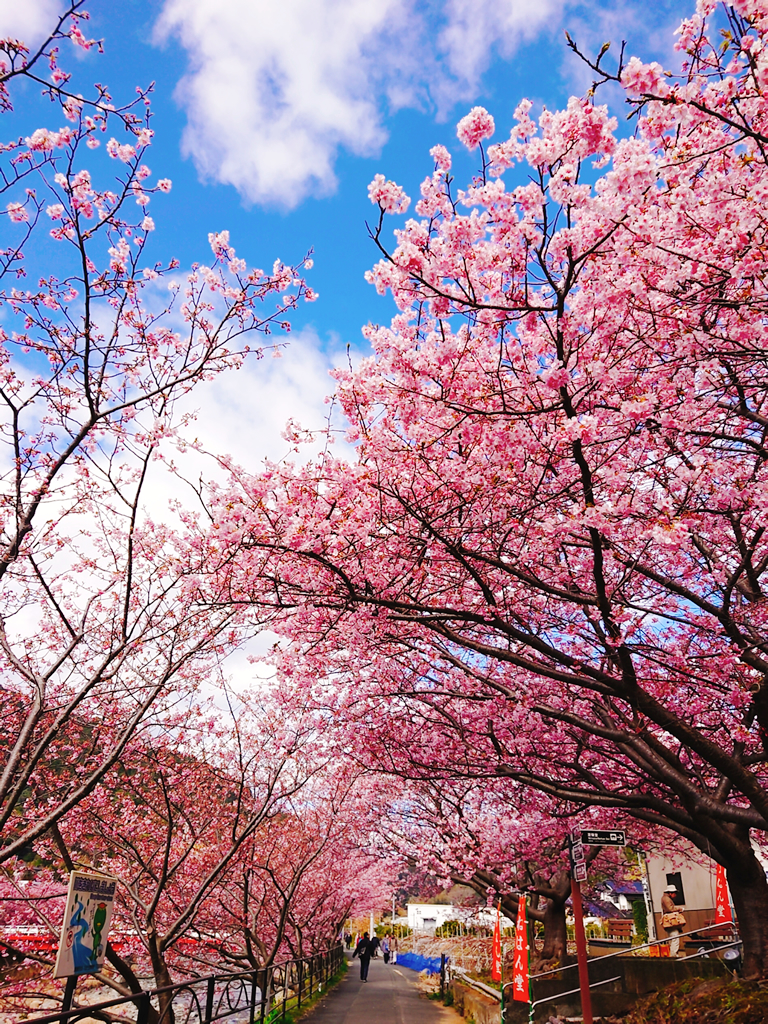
[158, 0, 404, 207]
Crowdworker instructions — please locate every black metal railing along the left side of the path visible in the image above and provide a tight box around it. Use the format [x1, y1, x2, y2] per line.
[26, 945, 344, 1024]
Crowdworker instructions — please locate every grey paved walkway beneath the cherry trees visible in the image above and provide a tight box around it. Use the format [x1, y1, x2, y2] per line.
[302, 958, 462, 1024]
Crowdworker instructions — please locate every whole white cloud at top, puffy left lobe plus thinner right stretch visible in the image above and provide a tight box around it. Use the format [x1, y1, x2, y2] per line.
[156, 0, 568, 208]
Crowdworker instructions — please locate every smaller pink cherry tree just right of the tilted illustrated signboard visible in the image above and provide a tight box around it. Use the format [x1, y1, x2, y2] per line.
[46, 700, 323, 1016]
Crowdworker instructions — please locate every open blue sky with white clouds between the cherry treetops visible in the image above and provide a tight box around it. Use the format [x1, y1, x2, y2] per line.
[0, 0, 692, 468]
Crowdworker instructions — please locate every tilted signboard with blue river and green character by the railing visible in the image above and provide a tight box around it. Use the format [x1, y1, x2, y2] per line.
[53, 871, 117, 978]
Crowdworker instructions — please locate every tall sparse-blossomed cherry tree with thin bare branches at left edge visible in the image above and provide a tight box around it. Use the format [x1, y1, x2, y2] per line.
[0, 0, 312, 861]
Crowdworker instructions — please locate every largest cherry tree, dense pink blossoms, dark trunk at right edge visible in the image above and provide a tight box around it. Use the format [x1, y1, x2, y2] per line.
[209, 0, 768, 976]
